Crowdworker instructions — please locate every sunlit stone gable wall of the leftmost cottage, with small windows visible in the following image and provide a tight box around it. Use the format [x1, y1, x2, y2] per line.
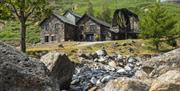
[41, 16, 65, 43]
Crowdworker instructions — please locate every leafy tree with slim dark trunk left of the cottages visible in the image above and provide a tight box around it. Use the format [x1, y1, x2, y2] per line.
[0, 0, 52, 52]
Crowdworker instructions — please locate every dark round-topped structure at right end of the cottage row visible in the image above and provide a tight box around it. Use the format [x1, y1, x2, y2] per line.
[111, 8, 139, 40]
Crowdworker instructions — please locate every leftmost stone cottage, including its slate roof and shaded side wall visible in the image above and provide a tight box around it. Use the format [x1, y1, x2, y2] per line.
[40, 14, 77, 43]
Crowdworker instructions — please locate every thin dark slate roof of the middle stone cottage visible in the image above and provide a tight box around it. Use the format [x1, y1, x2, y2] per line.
[77, 14, 111, 27]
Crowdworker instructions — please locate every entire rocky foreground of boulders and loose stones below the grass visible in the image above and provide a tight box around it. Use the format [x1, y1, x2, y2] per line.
[0, 42, 180, 91]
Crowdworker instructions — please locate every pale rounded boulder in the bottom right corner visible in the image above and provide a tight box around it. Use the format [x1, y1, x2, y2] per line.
[150, 70, 180, 91]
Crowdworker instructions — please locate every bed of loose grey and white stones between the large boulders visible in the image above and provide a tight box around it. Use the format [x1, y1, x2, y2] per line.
[71, 49, 150, 91]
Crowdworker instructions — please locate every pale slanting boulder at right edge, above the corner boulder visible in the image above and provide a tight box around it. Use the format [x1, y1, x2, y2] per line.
[142, 48, 180, 78]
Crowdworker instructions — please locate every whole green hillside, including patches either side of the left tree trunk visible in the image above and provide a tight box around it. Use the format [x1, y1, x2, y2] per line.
[0, 0, 180, 45]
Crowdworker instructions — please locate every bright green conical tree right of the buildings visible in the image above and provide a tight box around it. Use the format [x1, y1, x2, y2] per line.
[140, 3, 180, 50]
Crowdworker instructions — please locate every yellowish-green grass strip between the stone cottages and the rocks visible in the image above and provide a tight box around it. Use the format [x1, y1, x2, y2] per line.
[27, 39, 180, 62]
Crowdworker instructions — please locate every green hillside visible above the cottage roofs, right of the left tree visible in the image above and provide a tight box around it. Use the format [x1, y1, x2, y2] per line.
[55, 0, 180, 17]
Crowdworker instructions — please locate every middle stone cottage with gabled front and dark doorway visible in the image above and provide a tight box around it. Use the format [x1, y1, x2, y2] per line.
[76, 14, 111, 41]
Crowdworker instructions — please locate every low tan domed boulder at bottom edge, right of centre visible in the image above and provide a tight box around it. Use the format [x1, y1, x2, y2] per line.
[104, 77, 149, 91]
